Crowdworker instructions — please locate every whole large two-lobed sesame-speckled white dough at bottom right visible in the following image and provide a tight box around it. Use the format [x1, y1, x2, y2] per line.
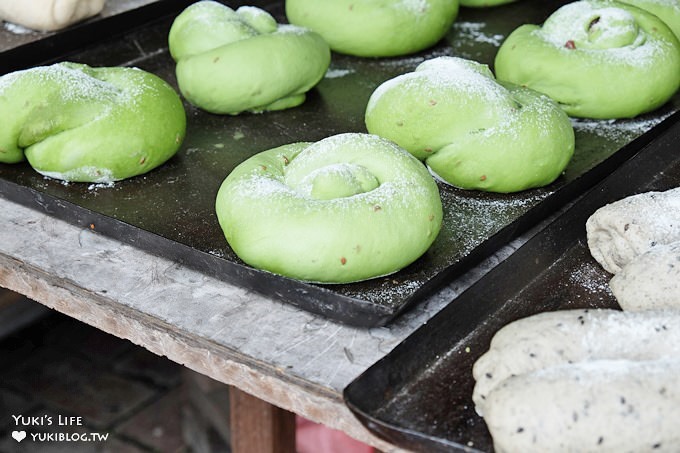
[473, 309, 680, 453]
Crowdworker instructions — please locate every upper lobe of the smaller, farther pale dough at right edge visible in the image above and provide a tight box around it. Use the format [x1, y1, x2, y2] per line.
[586, 188, 680, 274]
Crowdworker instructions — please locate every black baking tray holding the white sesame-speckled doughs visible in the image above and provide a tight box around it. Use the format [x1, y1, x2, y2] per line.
[344, 109, 680, 452]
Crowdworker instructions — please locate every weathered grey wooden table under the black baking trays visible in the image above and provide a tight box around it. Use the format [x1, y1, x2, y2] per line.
[0, 197, 528, 452]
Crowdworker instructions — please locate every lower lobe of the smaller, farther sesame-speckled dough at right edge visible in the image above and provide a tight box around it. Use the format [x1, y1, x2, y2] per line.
[609, 241, 680, 311]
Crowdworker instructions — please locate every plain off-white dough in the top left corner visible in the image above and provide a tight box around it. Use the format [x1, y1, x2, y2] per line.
[0, 0, 105, 31]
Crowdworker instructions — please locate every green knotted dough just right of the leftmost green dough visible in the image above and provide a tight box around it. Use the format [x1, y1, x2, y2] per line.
[168, 1, 330, 115]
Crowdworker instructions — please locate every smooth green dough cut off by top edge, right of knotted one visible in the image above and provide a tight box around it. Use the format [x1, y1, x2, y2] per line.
[286, 0, 458, 57]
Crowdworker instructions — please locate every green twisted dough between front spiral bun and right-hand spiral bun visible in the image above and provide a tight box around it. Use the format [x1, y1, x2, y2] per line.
[366, 57, 574, 192]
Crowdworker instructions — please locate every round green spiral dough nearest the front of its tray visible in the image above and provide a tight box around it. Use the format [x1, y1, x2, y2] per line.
[215, 133, 442, 283]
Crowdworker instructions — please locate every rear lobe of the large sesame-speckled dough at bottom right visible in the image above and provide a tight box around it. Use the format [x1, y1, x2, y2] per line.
[472, 310, 680, 417]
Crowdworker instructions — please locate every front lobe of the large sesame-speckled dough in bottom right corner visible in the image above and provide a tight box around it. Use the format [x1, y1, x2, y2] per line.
[484, 358, 680, 453]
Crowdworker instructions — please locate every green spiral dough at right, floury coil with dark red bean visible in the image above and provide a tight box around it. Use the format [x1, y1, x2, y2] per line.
[495, 0, 680, 119]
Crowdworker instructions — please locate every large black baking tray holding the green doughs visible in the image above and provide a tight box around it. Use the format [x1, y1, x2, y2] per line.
[0, 0, 680, 327]
